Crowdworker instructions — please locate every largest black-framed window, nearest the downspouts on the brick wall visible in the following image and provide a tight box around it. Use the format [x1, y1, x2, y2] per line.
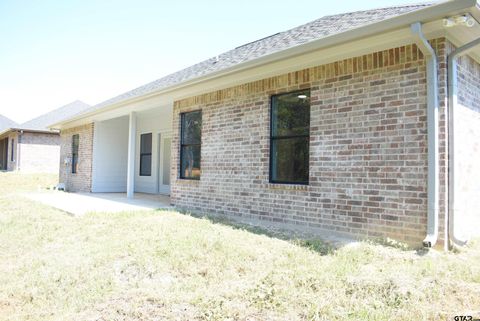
[270, 89, 310, 185]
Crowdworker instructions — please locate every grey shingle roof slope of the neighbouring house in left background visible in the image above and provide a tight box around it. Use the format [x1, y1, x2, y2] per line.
[20, 100, 91, 130]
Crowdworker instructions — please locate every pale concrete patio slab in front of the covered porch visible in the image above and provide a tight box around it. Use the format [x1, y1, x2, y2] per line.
[25, 191, 171, 215]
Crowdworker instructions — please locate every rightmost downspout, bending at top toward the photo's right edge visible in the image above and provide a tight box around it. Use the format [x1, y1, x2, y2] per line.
[445, 38, 480, 248]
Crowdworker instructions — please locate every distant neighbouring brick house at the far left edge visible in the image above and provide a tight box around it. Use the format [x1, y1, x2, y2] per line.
[0, 100, 90, 173]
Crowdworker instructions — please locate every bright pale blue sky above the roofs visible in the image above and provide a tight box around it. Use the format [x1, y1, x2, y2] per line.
[0, 0, 430, 122]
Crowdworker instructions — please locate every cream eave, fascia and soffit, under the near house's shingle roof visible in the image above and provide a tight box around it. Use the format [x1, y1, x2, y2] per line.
[51, 0, 478, 129]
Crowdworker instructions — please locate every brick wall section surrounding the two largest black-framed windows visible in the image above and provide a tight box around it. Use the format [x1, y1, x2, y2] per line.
[172, 39, 445, 244]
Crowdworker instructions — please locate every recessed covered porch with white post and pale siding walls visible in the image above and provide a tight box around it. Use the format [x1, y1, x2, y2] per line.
[91, 104, 173, 199]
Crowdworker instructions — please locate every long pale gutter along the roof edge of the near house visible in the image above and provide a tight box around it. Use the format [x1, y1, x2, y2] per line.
[49, 0, 477, 129]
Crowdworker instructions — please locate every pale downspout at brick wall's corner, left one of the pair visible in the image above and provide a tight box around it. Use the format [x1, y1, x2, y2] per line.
[411, 22, 439, 247]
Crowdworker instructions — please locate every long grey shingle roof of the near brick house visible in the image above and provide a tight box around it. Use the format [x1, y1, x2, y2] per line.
[79, 2, 435, 112]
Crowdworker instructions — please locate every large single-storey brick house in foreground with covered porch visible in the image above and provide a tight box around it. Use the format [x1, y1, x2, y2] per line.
[52, 0, 480, 246]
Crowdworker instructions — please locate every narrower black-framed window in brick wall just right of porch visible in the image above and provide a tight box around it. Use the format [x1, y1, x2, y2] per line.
[180, 110, 202, 179]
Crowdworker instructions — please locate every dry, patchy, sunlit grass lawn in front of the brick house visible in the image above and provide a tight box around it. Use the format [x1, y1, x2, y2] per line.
[0, 173, 480, 321]
